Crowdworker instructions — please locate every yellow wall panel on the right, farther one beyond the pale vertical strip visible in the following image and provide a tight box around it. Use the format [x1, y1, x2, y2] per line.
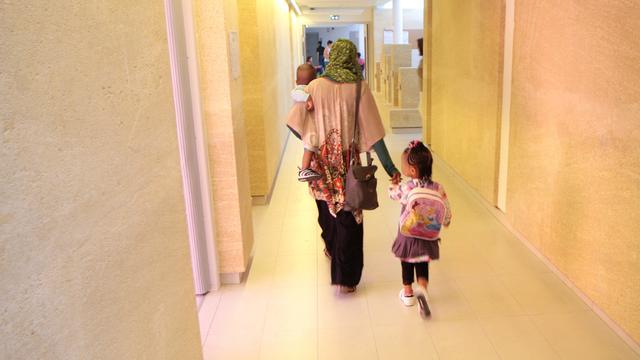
[425, 0, 504, 203]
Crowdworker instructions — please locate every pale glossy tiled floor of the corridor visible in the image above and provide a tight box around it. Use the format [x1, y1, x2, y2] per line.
[200, 97, 640, 360]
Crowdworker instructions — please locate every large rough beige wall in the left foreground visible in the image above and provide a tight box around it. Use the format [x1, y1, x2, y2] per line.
[0, 1, 202, 359]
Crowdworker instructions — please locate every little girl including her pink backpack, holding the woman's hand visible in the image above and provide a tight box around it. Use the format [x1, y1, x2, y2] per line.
[389, 140, 451, 316]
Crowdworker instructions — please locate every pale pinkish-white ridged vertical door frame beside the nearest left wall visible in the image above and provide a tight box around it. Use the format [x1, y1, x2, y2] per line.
[164, 0, 220, 295]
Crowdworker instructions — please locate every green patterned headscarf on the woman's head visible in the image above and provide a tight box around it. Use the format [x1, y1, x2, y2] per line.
[322, 39, 362, 83]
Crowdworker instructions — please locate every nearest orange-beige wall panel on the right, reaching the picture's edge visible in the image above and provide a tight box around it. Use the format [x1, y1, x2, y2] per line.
[507, 0, 640, 341]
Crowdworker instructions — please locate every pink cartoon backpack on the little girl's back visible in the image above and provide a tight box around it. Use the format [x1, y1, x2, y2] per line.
[400, 187, 447, 240]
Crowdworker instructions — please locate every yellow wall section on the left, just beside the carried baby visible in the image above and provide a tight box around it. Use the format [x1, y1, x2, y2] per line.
[237, 0, 294, 196]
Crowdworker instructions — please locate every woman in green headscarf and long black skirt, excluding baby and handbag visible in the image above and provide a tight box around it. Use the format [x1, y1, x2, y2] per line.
[287, 39, 400, 292]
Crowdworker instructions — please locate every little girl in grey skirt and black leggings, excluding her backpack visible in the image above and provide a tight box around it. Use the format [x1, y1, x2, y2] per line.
[389, 140, 451, 316]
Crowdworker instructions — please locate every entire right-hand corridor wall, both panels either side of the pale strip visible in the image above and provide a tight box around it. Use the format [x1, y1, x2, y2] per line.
[424, 0, 640, 341]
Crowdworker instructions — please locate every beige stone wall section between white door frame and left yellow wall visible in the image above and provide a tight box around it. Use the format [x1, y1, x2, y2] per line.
[194, 0, 253, 273]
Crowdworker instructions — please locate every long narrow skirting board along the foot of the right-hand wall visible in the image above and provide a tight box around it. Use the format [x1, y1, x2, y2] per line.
[433, 153, 640, 354]
